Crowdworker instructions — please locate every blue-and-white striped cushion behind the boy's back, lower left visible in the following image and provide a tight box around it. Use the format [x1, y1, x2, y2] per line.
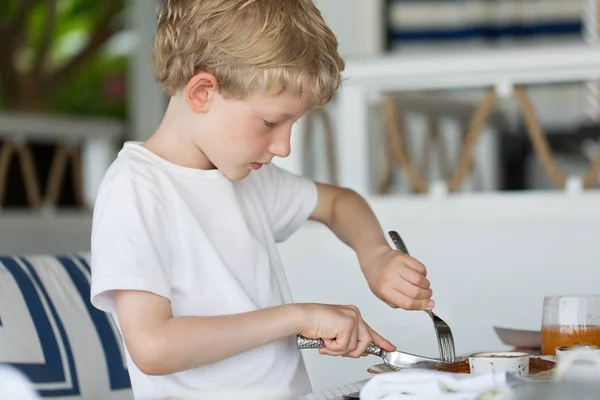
[0, 254, 133, 400]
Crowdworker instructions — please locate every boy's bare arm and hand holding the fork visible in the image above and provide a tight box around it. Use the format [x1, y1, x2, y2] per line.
[310, 183, 434, 310]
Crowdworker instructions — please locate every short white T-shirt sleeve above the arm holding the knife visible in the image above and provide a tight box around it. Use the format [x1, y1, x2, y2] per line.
[90, 176, 171, 313]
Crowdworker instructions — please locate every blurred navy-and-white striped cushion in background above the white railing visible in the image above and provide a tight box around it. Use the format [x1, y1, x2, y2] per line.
[387, 0, 584, 48]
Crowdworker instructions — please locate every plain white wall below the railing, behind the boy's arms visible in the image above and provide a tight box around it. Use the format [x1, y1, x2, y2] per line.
[280, 192, 600, 390]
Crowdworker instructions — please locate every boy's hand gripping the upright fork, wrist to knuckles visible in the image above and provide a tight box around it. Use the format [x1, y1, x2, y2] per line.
[360, 247, 435, 310]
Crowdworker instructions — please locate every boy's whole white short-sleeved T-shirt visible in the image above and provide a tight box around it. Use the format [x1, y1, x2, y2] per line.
[91, 142, 317, 399]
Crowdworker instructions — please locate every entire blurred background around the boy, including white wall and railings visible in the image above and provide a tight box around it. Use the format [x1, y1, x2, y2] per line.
[0, 0, 600, 396]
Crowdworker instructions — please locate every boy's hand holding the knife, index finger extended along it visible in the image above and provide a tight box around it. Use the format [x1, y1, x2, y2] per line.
[299, 304, 396, 358]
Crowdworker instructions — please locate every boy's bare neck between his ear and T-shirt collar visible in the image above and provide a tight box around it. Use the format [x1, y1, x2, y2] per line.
[143, 97, 215, 170]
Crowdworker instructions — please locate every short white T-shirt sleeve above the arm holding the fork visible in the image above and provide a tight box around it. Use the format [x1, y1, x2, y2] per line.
[263, 164, 317, 242]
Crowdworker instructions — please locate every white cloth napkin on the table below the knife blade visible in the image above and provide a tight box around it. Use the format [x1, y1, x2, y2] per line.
[360, 369, 512, 400]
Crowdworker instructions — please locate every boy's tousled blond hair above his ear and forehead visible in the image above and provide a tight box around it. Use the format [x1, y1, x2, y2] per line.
[152, 0, 344, 108]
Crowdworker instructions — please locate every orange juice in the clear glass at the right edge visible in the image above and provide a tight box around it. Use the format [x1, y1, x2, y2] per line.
[542, 325, 600, 355]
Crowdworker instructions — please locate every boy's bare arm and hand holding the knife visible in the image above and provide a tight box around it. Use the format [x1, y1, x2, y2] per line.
[114, 290, 396, 375]
